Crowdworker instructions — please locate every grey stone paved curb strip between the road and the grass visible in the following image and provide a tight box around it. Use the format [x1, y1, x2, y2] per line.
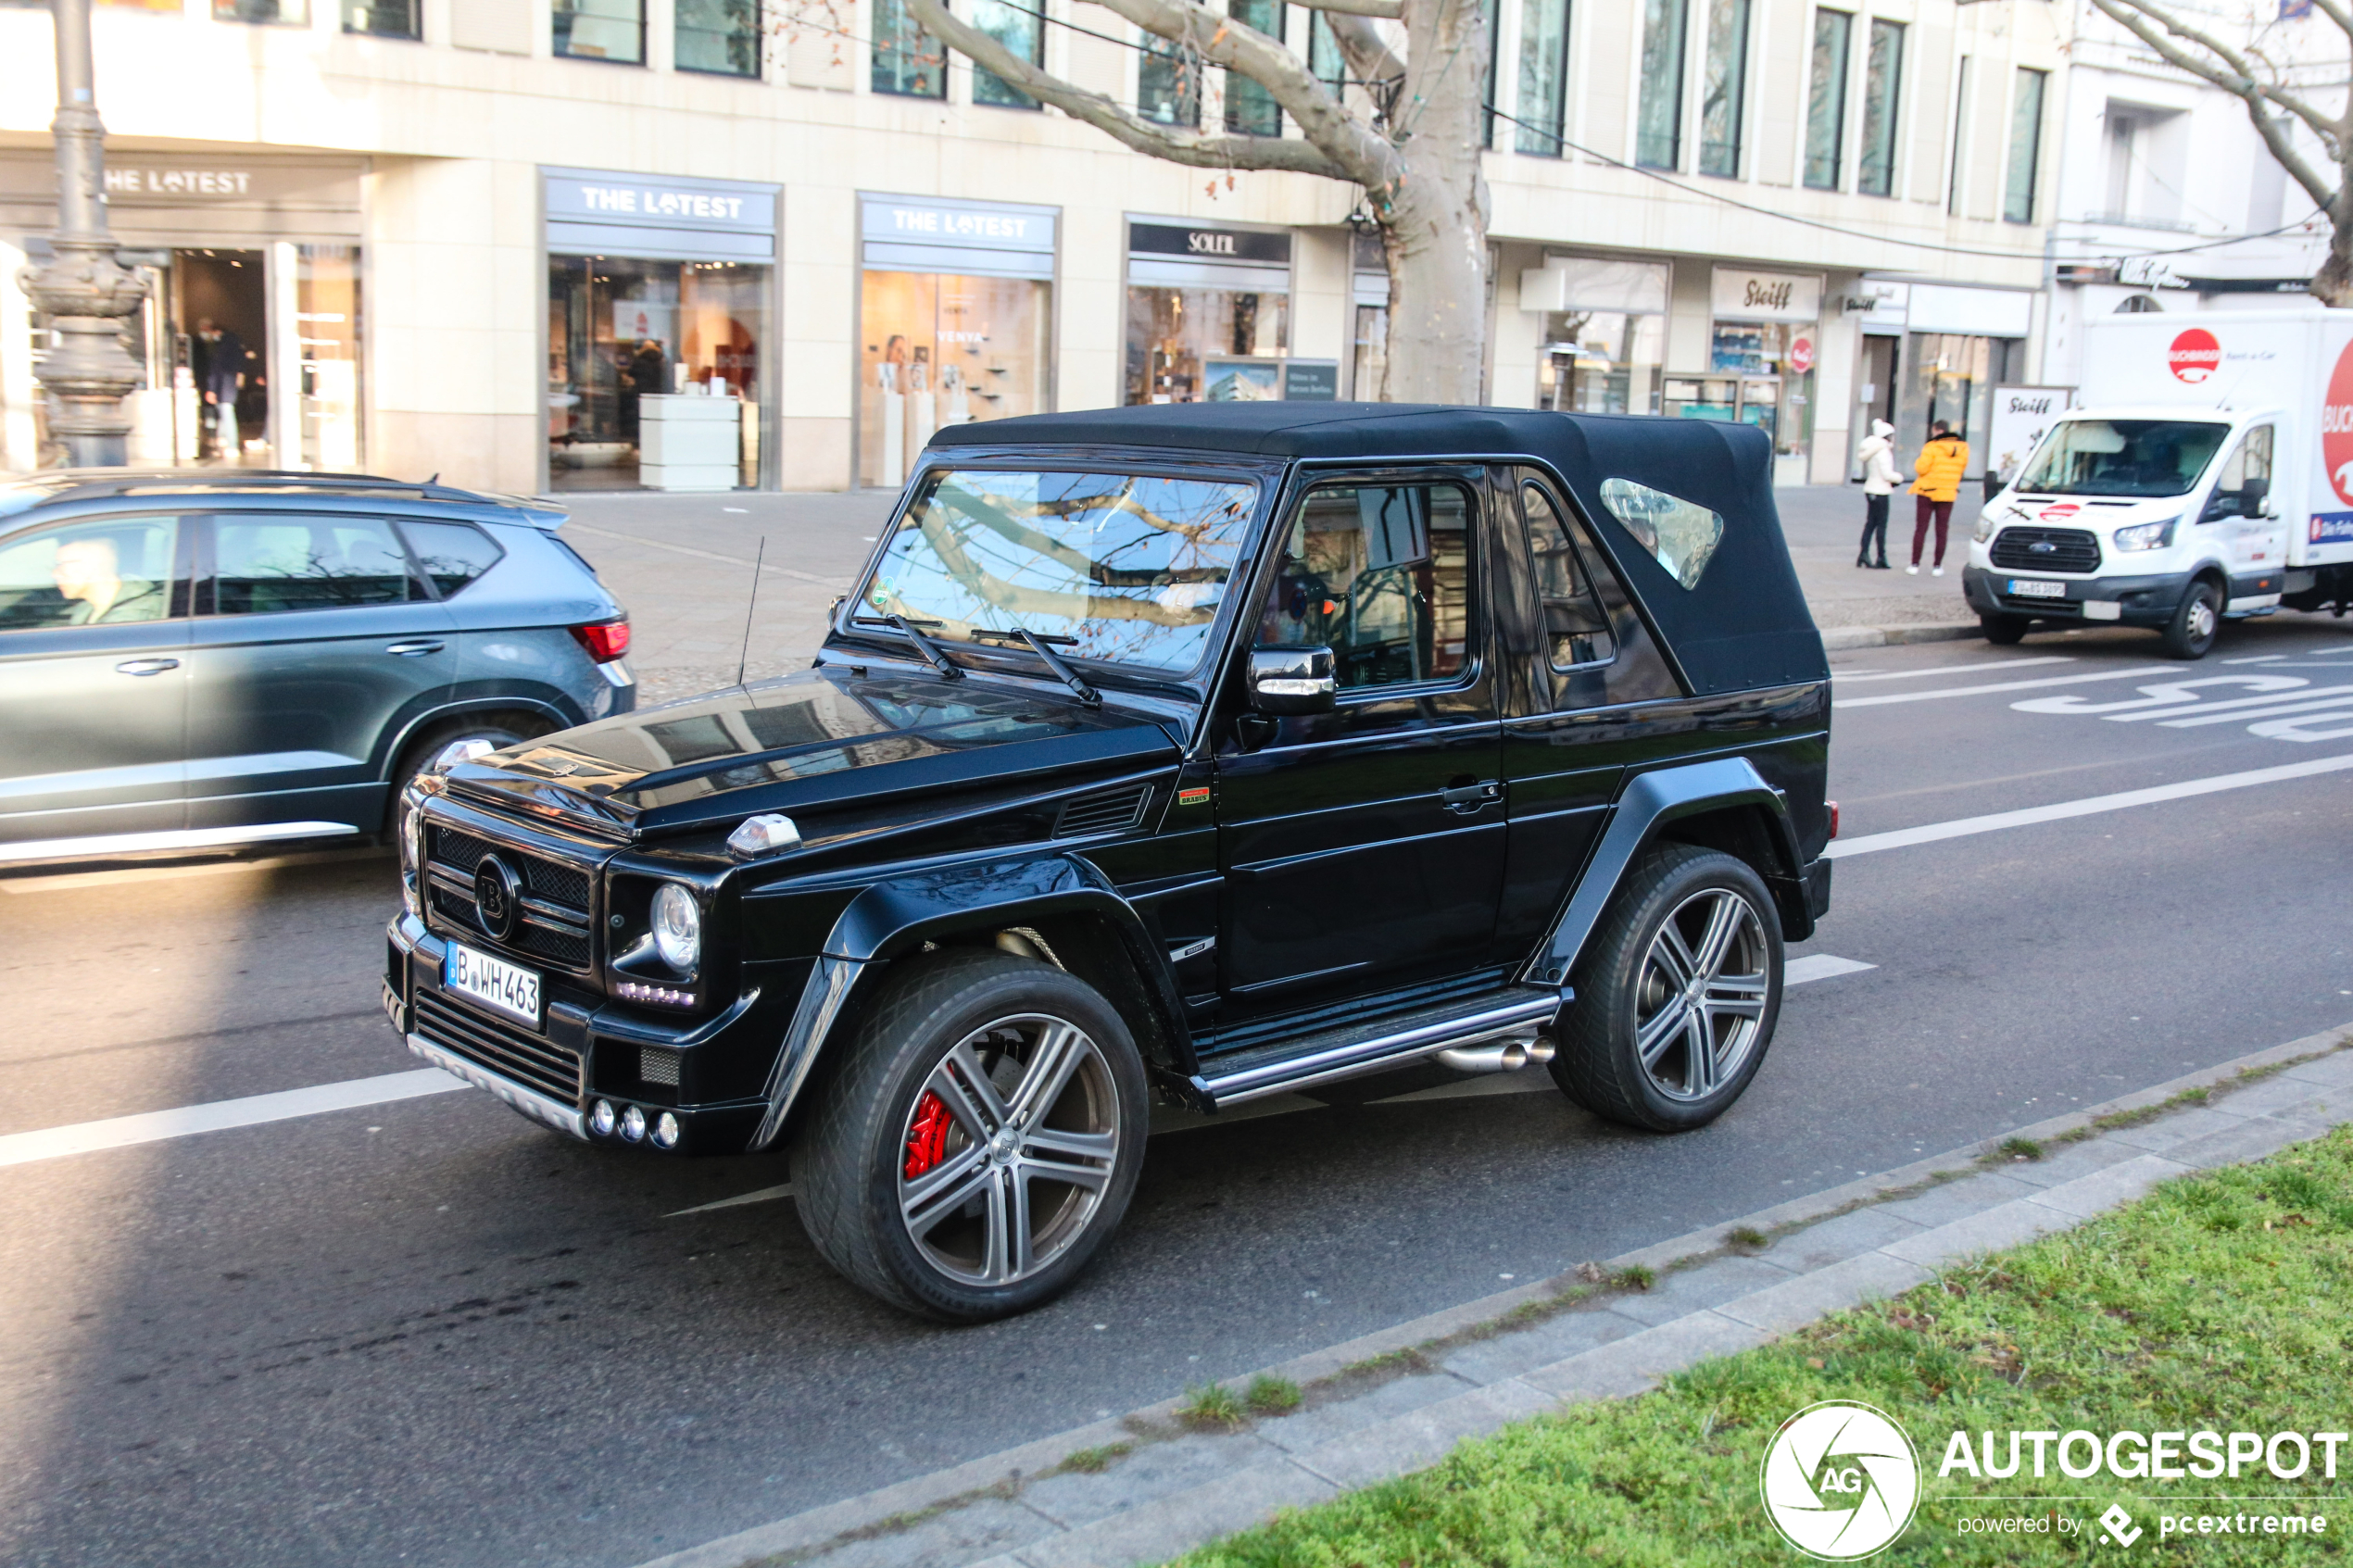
[642, 1025, 2353, 1568]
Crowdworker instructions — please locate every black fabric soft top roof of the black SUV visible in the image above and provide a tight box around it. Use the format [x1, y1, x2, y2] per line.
[932, 402, 1831, 694]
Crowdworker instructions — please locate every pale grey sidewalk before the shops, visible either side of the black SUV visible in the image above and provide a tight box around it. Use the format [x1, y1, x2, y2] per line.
[560, 484, 1979, 703]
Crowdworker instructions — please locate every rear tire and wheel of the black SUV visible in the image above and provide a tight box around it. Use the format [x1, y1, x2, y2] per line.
[1551, 844, 1781, 1133]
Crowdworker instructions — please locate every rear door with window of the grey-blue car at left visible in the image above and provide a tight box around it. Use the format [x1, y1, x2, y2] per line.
[188, 512, 457, 833]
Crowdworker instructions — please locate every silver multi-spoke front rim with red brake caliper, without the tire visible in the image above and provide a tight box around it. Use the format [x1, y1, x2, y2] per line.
[899, 1013, 1120, 1286]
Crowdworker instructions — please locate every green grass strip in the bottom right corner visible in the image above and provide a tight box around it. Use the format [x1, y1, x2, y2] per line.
[1181, 1128, 2353, 1568]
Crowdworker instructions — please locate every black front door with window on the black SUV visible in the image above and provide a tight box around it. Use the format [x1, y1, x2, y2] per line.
[1216, 468, 1504, 1025]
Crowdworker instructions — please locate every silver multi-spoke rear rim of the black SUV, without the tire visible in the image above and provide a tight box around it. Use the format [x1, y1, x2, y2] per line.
[1633, 886, 1772, 1100]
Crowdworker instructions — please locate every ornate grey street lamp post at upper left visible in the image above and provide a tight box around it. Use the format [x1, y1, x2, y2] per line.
[23, 0, 145, 468]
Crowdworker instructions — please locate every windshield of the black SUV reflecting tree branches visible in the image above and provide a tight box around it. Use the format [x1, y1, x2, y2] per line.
[857, 470, 1259, 672]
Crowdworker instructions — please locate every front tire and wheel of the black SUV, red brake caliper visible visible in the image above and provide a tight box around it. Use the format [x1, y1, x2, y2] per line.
[793, 949, 1151, 1323]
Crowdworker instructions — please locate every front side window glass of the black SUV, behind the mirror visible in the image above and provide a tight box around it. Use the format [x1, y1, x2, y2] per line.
[1259, 484, 1471, 691]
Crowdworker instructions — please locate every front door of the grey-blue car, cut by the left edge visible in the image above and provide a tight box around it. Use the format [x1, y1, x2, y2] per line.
[0, 517, 188, 860]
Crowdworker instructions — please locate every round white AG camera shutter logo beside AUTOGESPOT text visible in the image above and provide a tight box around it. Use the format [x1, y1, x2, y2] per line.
[1760, 1399, 1920, 1563]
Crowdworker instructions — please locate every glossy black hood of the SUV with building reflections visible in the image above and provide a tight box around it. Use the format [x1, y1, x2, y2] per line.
[449, 665, 1176, 834]
